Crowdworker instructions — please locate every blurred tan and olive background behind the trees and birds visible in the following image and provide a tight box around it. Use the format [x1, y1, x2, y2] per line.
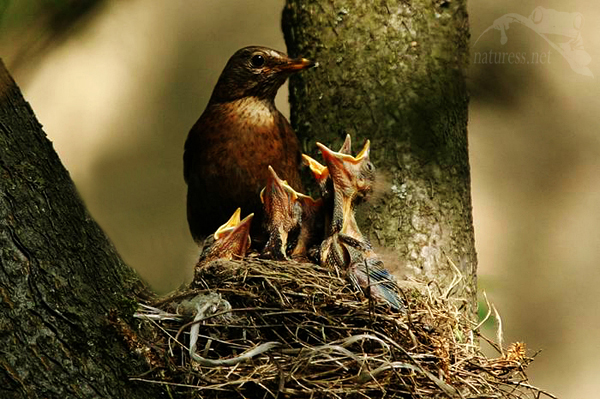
[0, 0, 600, 398]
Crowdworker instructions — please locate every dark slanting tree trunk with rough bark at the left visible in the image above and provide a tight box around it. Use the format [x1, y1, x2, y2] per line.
[0, 62, 157, 398]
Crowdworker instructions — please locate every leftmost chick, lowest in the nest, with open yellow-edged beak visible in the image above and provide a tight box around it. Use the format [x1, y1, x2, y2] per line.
[196, 208, 254, 271]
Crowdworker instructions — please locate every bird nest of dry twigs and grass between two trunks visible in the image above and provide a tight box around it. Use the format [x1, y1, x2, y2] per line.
[132, 259, 553, 398]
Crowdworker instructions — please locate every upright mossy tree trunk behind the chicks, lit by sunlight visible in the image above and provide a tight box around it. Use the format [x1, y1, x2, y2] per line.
[283, 0, 476, 315]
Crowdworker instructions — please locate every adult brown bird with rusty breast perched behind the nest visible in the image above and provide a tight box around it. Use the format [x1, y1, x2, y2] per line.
[183, 46, 314, 242]
